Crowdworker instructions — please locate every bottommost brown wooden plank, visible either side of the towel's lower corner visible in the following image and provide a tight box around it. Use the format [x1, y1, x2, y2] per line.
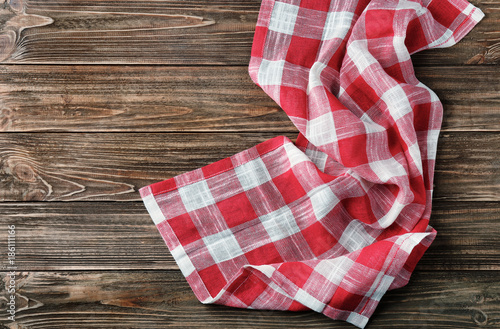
[0, 271, 500, 329]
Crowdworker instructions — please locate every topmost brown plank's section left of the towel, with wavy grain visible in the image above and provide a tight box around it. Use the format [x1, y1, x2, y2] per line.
[0, 0, 260, 65]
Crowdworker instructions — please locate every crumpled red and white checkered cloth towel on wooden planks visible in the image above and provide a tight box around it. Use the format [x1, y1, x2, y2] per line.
[140, 0, 483, 328]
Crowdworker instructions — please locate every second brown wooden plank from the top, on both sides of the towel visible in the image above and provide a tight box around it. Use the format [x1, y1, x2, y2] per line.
[0, 65, 500, 132]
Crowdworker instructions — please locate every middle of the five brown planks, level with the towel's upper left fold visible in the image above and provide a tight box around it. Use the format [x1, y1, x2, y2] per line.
[0, 132, 500, 201]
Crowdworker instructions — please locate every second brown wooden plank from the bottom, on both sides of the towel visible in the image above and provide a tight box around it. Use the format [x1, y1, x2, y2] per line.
[0, 202, 500, 271]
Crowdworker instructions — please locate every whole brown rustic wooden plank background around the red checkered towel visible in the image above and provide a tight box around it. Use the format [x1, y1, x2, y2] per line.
[0, 0, 500, 328]
